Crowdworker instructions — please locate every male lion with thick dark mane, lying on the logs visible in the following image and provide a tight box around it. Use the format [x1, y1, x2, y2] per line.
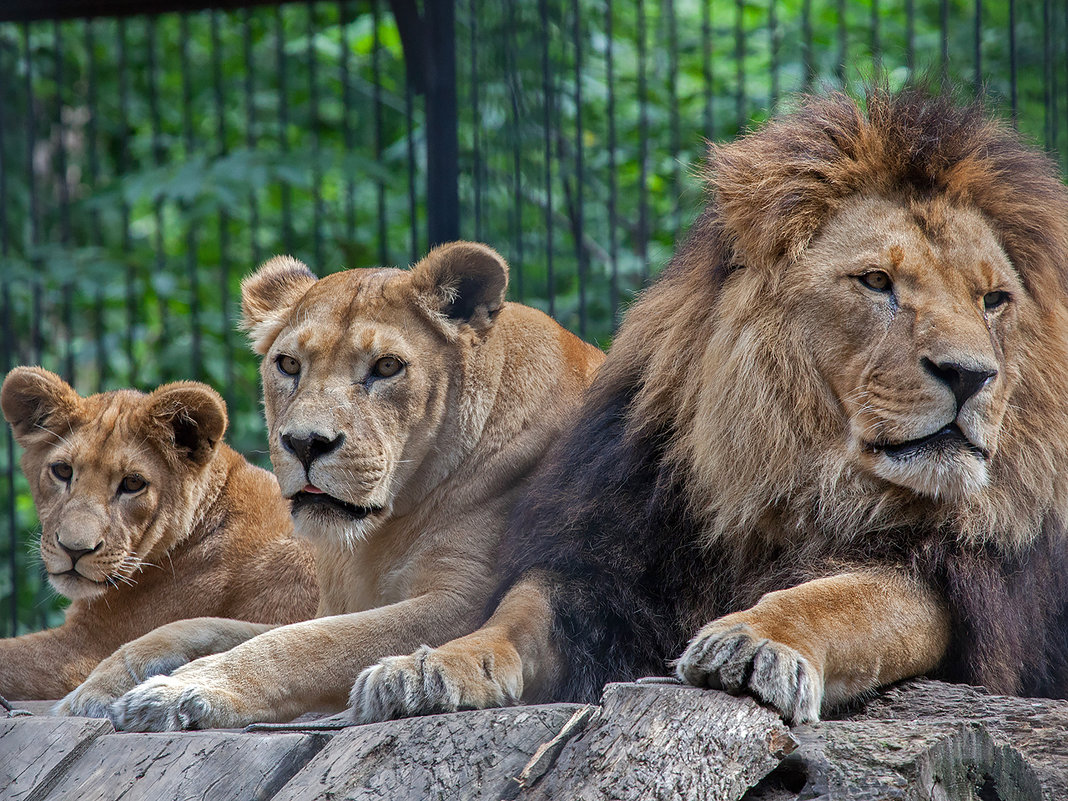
[352, 91, 1068, 722]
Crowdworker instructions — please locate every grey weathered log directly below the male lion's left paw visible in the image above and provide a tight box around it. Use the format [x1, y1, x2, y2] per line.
[276, 704, 585, 801]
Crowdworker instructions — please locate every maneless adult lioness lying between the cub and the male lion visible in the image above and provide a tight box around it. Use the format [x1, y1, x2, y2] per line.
[73, 242, 603, 729]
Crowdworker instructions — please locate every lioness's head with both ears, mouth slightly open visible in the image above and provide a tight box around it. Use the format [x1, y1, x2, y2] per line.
[242, 244, 506, 544]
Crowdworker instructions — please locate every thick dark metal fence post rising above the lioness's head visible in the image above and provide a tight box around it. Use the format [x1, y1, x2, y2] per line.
[390, 0, 459, 248]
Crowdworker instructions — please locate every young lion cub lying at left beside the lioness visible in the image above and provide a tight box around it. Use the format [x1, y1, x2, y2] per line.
[0, 367, 318, 700]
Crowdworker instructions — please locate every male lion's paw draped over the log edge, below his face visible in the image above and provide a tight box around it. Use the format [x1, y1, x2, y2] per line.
[676, 623, 823, 723]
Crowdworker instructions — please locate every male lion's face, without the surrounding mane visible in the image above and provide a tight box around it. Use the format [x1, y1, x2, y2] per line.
[784, 197, 1031, 498]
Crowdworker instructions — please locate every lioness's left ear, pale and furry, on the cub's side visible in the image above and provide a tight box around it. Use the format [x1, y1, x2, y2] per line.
[241, 256, 318, 356]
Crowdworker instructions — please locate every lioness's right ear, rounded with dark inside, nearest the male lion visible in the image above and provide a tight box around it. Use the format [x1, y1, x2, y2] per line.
[411, 242, 508, 328]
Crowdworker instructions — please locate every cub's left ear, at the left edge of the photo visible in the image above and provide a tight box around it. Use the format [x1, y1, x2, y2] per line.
[0, 367, 81, 447]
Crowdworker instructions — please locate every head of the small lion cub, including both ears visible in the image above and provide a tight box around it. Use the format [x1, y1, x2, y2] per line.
[0, 367, 225, 599]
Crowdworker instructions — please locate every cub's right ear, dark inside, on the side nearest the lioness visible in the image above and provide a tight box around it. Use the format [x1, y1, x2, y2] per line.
[147, 381, 226, 465]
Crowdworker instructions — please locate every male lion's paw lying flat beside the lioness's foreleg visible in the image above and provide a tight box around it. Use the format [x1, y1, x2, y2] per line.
[349, 645, 522, 723]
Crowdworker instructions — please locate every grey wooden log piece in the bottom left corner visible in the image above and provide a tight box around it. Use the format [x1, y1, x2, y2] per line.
[0, 717, 115, 801]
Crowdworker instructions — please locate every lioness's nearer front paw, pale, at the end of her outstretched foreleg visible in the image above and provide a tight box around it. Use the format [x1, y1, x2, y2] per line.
[108, 676, 245, 732]
